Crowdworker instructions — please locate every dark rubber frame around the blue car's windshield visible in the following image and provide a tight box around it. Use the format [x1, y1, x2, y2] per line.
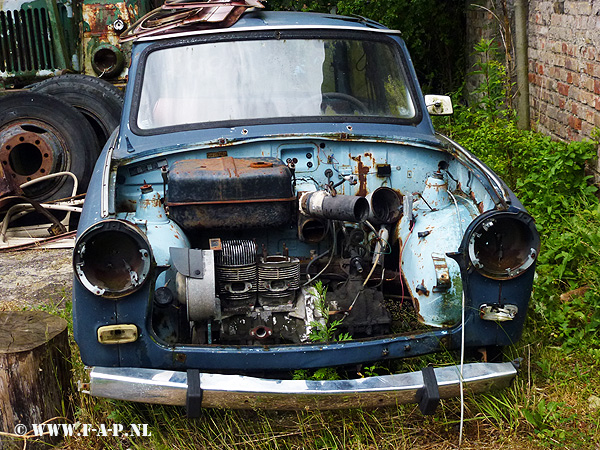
[128, 29, 423, 136]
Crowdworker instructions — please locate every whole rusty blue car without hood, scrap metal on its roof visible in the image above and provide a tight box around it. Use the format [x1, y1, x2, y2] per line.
[73, 1, 540, 417]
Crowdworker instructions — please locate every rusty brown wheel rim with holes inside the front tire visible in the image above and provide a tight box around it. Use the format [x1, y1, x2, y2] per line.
[0, 119, 70, 198]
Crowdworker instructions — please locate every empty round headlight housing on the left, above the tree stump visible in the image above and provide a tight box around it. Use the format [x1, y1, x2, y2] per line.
[73, 220, 152, 298]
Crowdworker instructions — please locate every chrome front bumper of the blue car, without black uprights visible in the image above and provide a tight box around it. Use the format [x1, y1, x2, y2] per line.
[89, 363, 517, 410]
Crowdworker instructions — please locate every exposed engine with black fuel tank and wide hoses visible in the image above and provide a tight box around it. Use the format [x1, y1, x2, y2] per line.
[136, 158, 402, 344]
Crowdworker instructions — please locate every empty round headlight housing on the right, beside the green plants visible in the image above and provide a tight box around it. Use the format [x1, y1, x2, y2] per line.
[468, 211, 540, 280]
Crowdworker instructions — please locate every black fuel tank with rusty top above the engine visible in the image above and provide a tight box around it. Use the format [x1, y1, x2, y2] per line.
[166, 157, 296, 229]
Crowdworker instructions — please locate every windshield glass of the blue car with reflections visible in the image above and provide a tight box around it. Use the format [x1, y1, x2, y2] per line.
[137, 35, 415, 130]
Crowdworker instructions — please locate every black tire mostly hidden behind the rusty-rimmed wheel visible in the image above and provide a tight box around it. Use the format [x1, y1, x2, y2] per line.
[31, 75, 123, 154]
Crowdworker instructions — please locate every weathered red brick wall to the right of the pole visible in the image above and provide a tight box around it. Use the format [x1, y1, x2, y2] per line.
[528, 0, 600, 140]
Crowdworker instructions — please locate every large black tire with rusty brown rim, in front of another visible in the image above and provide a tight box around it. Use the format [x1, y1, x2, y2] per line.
[0, 92, 98, 202]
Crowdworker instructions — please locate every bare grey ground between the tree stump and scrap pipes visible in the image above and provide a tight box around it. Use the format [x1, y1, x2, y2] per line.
[0, 249, 73, 310]
